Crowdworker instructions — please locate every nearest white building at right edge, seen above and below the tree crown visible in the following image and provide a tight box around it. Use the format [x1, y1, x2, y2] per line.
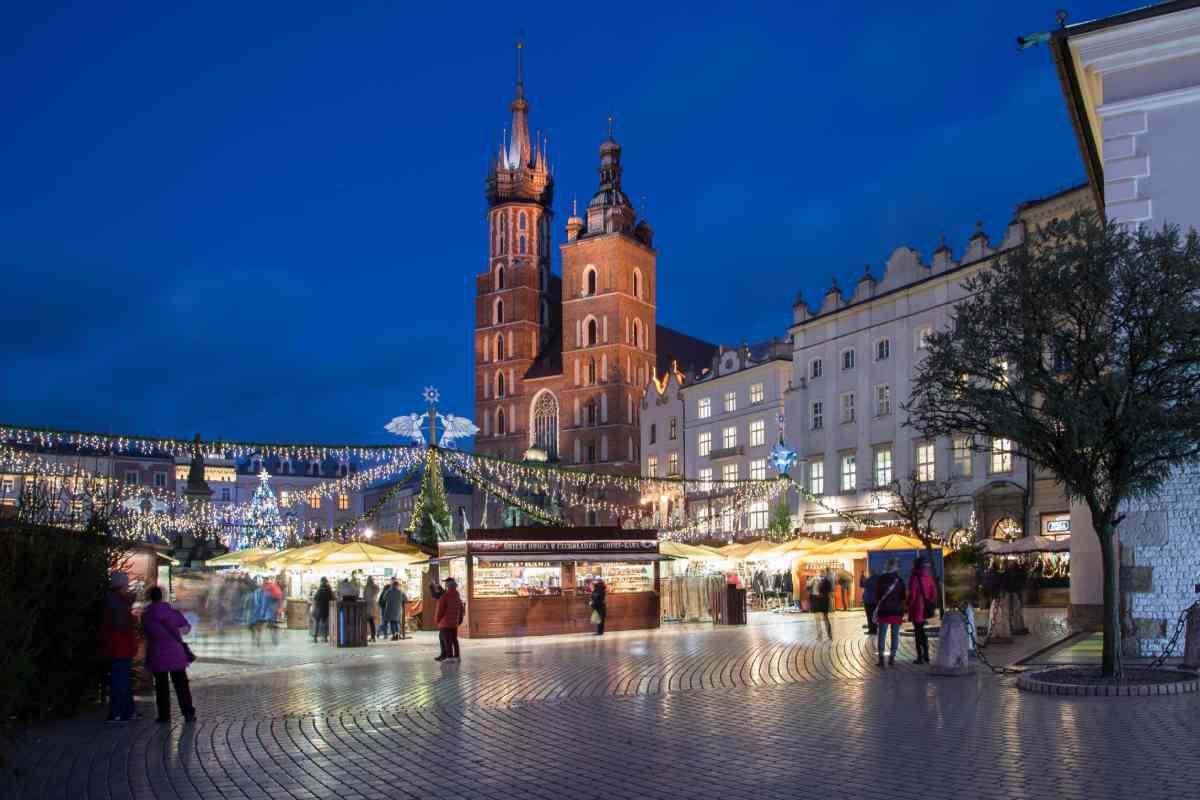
[1051, 1, 1200, 655]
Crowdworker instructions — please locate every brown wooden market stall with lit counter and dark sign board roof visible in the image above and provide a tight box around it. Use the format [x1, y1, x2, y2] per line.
[434, 528, 668, 637]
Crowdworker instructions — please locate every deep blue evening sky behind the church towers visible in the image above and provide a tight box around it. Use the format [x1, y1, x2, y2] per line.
[0, 0, 1133, 443]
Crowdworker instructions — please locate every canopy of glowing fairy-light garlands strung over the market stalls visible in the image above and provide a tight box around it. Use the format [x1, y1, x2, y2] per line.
[0, 426, 897, 546]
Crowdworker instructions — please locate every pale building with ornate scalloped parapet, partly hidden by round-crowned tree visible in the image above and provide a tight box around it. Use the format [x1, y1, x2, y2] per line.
[786, 187, 1090, 537]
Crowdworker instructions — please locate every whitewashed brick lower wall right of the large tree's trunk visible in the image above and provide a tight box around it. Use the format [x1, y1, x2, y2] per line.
[1120, 464, 1200, 656]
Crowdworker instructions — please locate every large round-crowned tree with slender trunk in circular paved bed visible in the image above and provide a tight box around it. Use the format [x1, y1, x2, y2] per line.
[905, 215, 1200, 676]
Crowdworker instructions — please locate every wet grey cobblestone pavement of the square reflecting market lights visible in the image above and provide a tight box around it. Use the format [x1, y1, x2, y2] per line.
[0, 612, 1200, 800]
